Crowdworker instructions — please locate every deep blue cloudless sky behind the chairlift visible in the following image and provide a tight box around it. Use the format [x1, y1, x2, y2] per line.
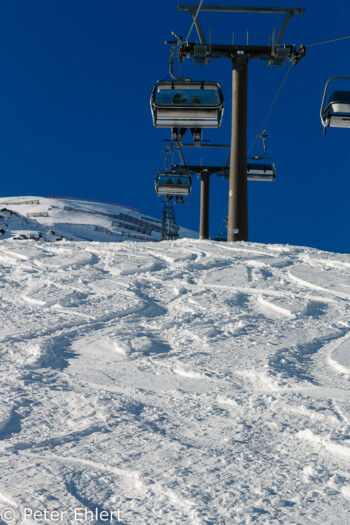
[0, 0, 350, 253]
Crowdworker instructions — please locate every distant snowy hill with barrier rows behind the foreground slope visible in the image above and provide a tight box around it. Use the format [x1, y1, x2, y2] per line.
[0, 196, 198, 242]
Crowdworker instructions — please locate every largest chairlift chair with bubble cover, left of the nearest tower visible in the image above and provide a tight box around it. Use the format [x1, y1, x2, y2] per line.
[151, 80, 224, 128]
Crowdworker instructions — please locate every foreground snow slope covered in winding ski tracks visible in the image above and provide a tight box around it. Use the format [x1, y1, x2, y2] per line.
[0, 239, 350, 525]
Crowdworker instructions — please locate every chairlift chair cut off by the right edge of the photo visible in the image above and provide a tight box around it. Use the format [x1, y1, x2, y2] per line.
[320, 77, 350, 133]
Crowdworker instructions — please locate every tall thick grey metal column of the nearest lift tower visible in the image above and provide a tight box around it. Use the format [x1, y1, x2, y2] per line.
[227, 55, 248, 242]
